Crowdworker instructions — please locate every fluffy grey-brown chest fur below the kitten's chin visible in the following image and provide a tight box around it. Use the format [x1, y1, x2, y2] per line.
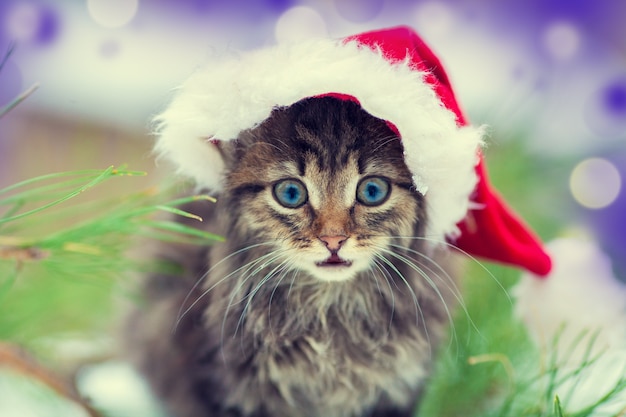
[206, 264, 434, 417]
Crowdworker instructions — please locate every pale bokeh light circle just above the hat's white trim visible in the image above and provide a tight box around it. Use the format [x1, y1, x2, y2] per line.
[274, 6, 328, 43]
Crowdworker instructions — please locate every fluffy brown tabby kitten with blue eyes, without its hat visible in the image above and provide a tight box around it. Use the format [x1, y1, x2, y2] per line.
[128, 97, 455, 417]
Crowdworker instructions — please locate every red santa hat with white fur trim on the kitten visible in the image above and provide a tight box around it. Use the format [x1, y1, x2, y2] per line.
[156, 27, 551, 276]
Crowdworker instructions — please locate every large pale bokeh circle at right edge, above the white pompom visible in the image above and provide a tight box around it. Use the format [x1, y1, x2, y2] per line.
[569, 158, 622, 209]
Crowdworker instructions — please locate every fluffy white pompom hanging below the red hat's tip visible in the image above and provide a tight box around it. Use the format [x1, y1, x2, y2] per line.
[513, 238, 626, 416]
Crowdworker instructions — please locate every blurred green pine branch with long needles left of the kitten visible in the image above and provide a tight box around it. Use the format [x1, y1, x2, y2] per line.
[0, 167, 222, 349]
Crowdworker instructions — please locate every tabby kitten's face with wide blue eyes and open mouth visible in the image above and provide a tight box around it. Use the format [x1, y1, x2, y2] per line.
[225, 98, 425, 281]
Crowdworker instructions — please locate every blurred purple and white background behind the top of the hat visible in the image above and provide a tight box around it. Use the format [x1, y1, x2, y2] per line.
[0, 0, 626, 276]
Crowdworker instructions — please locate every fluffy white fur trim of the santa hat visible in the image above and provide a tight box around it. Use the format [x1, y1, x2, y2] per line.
[155, 39, 482, 244]
